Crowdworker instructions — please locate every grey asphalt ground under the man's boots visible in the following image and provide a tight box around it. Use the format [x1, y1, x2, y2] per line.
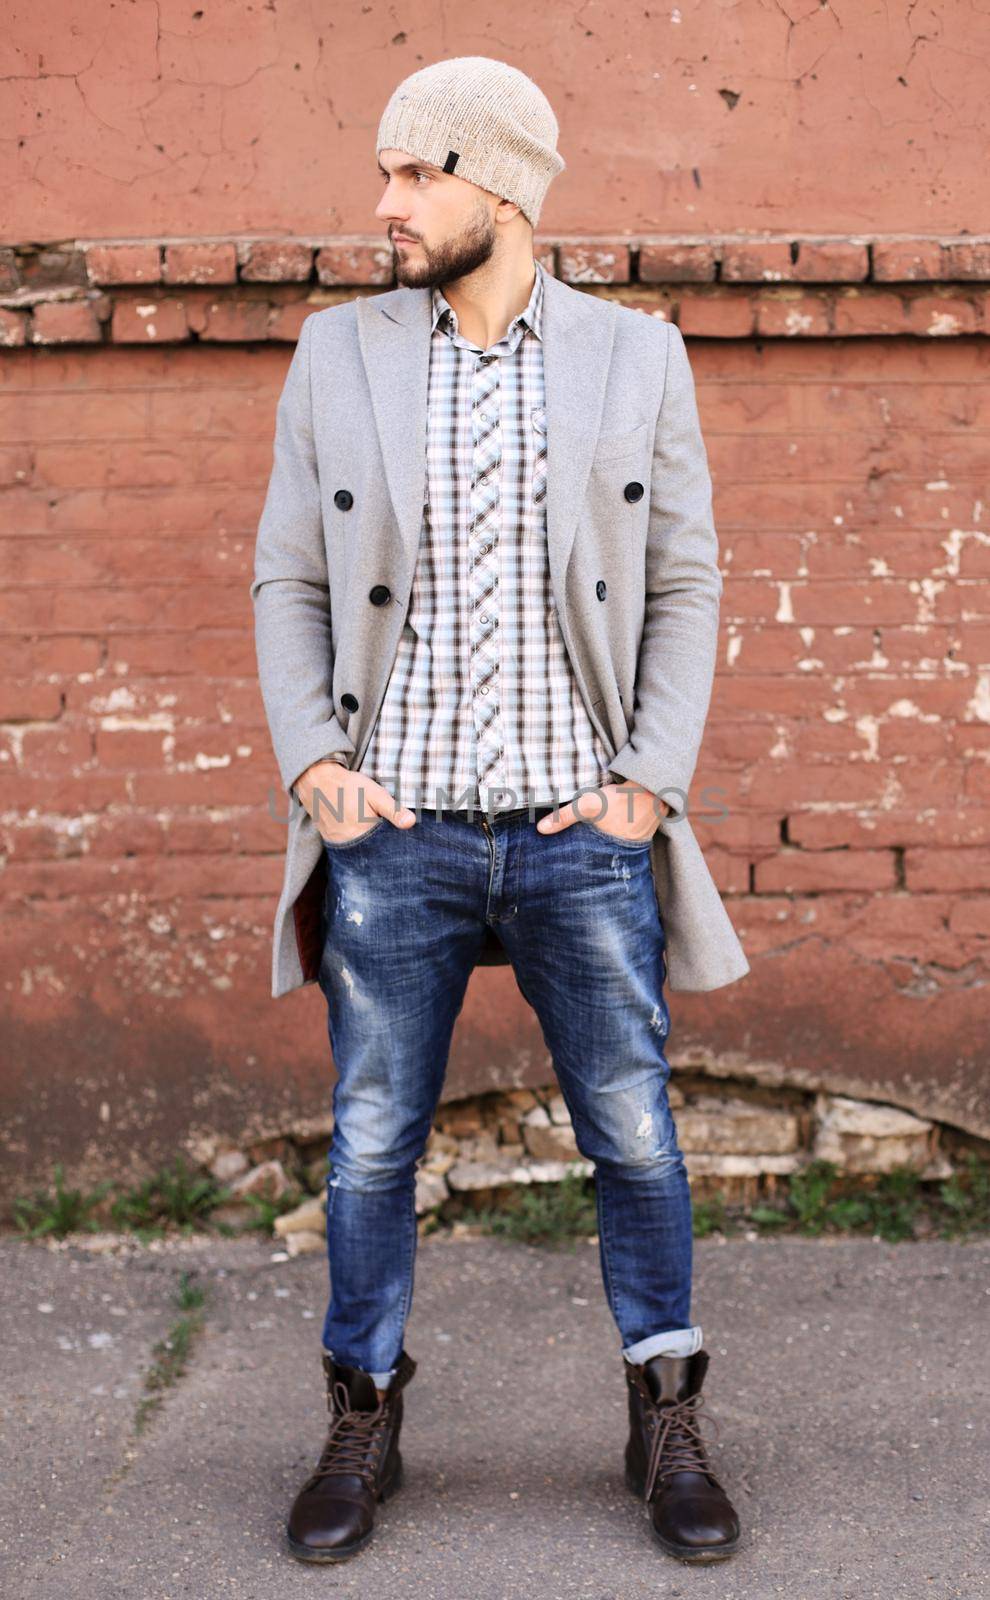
[0, 1235, 990, 1600]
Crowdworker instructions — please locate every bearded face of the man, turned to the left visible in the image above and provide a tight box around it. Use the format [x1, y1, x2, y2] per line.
[374, 150, 508, 290]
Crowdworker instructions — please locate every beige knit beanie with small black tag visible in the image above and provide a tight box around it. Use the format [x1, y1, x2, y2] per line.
[377, 56, 566, 227]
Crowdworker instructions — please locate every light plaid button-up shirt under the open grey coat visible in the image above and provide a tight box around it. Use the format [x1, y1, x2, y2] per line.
[332, 262, 609, 813]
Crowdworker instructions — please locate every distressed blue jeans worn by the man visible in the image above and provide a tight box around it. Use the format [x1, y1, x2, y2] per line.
[320, 806, 702, 1389]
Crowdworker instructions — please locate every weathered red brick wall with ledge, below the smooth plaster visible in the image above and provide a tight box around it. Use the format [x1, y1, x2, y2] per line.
[0, 242, 990, 1203]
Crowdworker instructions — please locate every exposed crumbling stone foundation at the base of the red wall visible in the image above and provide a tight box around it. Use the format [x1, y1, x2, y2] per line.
[182, 1070, 990, 1256]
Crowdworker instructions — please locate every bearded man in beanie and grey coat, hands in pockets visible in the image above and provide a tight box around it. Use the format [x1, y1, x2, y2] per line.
[251, 56, 748, 1562]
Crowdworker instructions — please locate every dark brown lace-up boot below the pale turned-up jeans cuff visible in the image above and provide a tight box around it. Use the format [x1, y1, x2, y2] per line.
[624, 1350, 739, 1562]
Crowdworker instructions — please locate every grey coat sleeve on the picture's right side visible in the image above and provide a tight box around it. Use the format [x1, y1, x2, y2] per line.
[609, 323, 721, 813]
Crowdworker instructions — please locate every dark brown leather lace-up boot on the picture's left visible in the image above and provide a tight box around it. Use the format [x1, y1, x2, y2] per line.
[288, 1350, 416, 1562]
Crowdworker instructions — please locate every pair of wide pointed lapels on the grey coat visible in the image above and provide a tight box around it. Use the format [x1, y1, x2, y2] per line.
[357, 272, 616, 618]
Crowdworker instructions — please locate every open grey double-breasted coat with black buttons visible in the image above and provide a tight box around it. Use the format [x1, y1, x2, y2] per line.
[251, 277, 748, 997]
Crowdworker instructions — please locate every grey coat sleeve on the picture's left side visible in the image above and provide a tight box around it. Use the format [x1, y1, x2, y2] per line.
[251, 312, 353, 792]
